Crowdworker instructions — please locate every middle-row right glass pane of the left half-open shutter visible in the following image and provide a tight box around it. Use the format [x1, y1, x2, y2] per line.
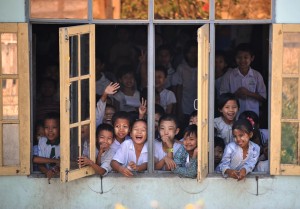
[81, 79, 90, 121]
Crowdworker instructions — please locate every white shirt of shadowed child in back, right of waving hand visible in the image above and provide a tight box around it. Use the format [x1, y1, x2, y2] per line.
[114, 90, 141, 112]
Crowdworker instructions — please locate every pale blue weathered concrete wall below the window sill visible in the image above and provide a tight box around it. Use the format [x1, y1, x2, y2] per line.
[0, 176, 300, 209]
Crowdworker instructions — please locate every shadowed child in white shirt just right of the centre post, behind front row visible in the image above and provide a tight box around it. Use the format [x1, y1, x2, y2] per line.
[155, 66, 176, 114]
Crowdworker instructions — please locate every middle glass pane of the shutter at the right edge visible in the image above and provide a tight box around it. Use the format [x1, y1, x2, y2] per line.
[282, 78, 298, 119]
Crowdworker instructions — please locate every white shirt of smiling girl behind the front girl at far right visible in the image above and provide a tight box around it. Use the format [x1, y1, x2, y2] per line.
[214, 117, 234, 144]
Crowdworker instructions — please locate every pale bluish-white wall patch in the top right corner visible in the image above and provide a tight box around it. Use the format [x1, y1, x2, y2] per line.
[275, 0, 300, 23]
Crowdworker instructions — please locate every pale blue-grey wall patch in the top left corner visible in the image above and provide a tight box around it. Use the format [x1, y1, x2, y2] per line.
[0, 0, 26, 22]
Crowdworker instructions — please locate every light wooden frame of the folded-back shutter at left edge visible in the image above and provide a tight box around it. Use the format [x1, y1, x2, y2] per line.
[0, 23, 31, 175]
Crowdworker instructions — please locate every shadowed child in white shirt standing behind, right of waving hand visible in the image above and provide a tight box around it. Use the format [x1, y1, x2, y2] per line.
[114, 65, 140, 112]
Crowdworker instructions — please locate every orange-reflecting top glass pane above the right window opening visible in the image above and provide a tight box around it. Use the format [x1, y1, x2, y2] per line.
[215, 0, 272, 19]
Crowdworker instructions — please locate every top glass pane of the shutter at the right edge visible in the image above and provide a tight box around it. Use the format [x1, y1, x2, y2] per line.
[282, 33, 300, 74]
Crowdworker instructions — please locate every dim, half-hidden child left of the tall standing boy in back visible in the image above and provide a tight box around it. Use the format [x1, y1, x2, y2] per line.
[215, 51, 227, 98]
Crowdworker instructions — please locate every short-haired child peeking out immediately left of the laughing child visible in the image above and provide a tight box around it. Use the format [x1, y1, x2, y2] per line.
[111, 111, 130, 153]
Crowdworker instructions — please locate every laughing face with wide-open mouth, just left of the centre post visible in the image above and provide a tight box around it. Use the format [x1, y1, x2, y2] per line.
[130, 121, 147, 144]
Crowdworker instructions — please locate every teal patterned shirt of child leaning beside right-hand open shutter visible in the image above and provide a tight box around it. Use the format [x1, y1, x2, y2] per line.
[173, 146, 198, 178]
